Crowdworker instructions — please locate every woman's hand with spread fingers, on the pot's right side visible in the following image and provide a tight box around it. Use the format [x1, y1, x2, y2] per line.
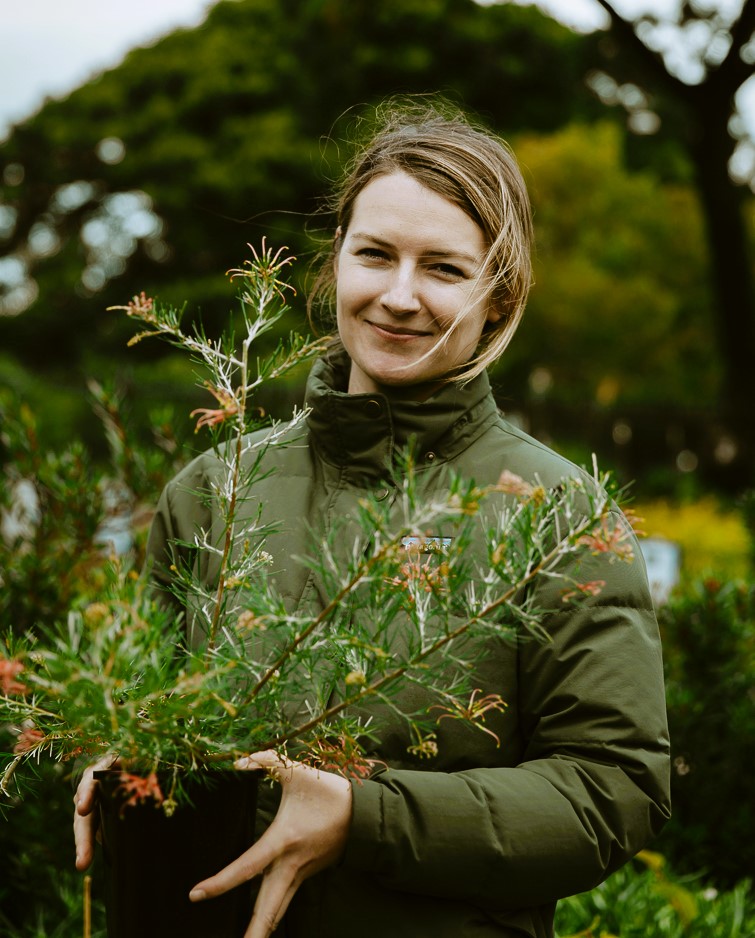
[189, 752, 351, 938]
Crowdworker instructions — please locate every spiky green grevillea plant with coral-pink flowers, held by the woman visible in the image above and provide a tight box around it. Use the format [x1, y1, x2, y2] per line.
[0, 243, 632, 812]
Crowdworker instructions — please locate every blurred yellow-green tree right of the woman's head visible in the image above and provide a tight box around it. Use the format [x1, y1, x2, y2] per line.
[501, 123, 720, 406]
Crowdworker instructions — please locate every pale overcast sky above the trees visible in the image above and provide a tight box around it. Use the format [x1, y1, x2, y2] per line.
[0, 0, 755, 141]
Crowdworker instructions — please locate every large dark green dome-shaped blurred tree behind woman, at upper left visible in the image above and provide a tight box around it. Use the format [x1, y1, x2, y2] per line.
[0, 0, 600, 374]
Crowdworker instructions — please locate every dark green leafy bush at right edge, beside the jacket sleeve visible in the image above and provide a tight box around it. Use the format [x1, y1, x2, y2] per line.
[659, 578, 755, 886]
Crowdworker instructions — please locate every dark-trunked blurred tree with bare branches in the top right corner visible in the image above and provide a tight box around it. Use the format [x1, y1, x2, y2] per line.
[591, 0, 755, 485]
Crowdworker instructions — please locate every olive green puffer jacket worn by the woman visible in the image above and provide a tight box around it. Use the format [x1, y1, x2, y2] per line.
[149, 356, 669, 938]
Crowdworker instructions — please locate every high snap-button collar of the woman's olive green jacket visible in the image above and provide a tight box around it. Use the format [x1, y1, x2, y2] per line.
[306, 350, 498, 484]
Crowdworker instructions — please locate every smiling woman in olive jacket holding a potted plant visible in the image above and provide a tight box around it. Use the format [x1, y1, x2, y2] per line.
[75, 100, 668, 938]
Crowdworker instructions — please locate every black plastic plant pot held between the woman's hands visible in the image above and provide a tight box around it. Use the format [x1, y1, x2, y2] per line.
[95, 770, 258, 938]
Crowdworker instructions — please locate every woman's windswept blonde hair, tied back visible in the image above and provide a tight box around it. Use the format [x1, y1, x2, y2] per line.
[307, 98, 533, 382]
